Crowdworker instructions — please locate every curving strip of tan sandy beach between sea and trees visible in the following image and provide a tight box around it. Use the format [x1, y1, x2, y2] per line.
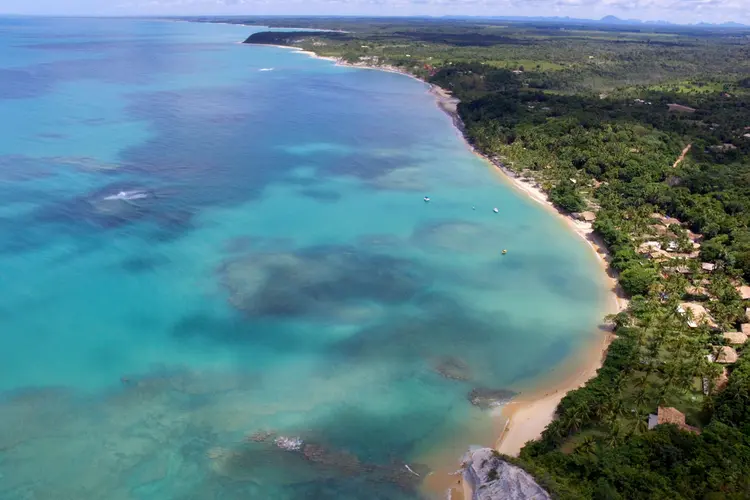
[247, 42, 628, 500]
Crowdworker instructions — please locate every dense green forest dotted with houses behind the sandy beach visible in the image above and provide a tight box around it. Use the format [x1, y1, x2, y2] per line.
[237, 19, 750, 499]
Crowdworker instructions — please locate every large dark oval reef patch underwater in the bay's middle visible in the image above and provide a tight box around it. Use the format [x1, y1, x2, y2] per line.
[219, 246, 430, 320]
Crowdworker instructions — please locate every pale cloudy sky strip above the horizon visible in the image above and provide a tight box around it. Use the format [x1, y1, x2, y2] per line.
[0, 0, 750, 23]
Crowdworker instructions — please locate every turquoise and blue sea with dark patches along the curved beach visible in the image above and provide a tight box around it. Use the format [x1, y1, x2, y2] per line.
[0, 18, 604, 500]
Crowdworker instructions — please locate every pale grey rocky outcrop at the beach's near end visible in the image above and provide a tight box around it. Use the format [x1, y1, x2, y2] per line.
[463, 448, 550, 500]
